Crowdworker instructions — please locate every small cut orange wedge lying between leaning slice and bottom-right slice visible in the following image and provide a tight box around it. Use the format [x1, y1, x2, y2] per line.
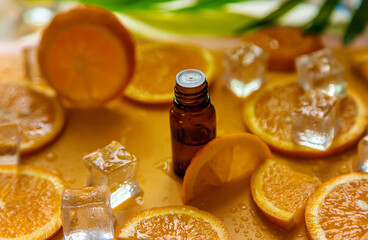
[251, 159, 320, 229]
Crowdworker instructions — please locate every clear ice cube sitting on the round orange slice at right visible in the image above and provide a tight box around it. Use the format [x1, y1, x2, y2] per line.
[291, 90, 339, 150]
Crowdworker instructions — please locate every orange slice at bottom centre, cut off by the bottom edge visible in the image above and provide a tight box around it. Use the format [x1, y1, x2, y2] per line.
[117, 206, 231, 240]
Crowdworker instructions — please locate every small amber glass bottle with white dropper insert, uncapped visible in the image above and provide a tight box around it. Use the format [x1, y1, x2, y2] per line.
[170, 69, 216, 178]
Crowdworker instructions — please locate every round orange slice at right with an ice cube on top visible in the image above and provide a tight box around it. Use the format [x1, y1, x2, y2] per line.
[243, 79, 368, 157]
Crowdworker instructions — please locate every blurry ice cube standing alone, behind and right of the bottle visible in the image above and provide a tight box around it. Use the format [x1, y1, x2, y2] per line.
[223, 43, 268, 97]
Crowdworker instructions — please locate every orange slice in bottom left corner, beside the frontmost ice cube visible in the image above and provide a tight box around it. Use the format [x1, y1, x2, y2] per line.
[0, 165, 65, 240]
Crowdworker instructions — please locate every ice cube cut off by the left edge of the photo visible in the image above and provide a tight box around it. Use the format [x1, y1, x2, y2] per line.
[0, 123, 20, 165]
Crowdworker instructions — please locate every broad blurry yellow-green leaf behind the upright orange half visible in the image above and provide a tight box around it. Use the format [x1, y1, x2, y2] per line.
[121, 10, 255, 37]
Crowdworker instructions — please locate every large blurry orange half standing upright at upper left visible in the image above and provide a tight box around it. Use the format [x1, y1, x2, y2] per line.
[38, 5, 135, 106]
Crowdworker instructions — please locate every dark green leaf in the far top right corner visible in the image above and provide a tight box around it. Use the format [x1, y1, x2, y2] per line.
[343, 0, 368, 44]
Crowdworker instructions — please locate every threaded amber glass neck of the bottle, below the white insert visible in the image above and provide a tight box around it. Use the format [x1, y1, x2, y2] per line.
[174, 81, 210, 108]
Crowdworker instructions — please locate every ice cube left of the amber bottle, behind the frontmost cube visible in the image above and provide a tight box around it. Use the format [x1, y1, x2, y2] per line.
[83, 141, 140, 208]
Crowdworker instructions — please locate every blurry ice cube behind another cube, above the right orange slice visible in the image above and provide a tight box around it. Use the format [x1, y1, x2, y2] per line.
[296, 48, 346, 97]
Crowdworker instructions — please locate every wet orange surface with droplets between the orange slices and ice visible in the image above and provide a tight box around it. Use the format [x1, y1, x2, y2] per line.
[15, 49, 366, 240]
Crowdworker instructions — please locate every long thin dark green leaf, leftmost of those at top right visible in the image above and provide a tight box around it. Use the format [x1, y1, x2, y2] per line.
[236, 0, 304, 33]
